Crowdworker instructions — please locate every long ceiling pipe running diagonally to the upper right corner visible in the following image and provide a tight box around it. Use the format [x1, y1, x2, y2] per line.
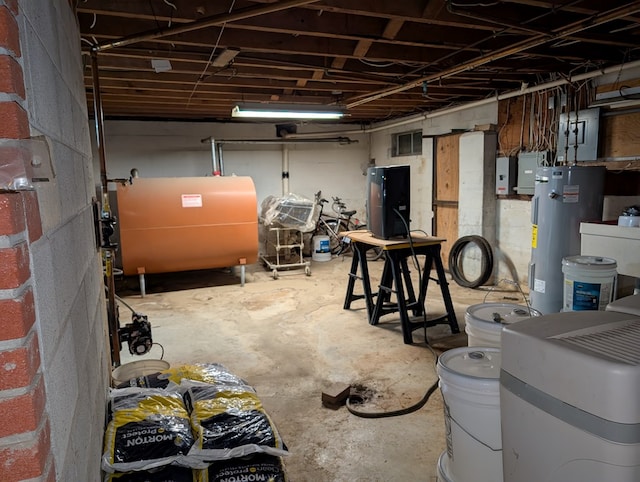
[346, 1, 640, 109]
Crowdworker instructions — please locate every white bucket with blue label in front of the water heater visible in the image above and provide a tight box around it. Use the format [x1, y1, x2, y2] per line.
[562, 256, 617, 311]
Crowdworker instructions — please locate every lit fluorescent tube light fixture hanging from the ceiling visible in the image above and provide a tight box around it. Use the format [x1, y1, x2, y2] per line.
[231, 103, 345, 119]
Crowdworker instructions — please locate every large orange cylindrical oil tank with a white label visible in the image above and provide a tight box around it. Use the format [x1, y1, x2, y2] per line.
[117, 176, 258, 275]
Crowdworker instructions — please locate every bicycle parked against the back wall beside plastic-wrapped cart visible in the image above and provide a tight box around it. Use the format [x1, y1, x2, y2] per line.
[313, 191, 384, 261]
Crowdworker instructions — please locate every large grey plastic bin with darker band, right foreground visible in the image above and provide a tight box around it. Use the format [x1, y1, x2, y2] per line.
[500, 311, 640, 482]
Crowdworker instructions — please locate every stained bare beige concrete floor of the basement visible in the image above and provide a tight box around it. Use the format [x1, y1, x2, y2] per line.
[117, 254, 510, 482]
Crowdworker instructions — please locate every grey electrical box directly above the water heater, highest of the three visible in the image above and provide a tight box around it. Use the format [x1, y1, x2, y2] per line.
[558, 108, 600, 164]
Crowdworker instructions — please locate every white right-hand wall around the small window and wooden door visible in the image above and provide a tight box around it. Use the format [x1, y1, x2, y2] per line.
[370, 106, 531, 286]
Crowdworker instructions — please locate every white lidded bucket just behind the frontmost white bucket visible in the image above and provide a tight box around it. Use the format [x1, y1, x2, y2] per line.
[464, 303, 540, 348]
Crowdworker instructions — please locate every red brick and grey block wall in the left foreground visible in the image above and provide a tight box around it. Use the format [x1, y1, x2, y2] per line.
[0, 0, 110, 482]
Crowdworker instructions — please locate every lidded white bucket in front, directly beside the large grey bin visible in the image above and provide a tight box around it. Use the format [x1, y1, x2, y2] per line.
[437, 347, 502, 482]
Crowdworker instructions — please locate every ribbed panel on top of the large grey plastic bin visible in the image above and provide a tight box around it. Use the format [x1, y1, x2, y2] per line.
[556, 320, 640, 365]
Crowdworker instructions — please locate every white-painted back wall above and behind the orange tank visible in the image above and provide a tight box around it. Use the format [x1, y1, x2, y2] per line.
[94, 121, 368, 218]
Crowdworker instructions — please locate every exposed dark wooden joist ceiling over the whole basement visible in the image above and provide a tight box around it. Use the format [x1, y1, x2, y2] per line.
[77, 0, 640, 123]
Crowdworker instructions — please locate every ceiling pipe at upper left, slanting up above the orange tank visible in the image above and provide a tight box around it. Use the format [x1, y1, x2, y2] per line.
[94, 0, 318, 52]
